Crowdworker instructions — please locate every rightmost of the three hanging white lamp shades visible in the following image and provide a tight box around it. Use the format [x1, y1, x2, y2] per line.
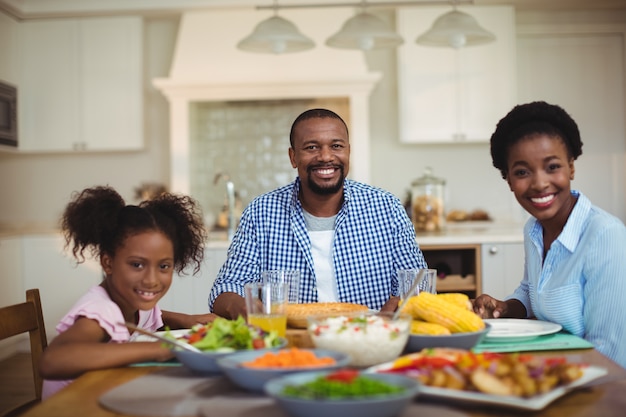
[415, 10, 496, 49]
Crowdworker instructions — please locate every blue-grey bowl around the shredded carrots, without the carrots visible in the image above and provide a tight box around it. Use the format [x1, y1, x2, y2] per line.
[217, 349, 350, 392]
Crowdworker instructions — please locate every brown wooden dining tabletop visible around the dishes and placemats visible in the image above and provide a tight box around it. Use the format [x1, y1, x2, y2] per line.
[23, 331, 626, 417]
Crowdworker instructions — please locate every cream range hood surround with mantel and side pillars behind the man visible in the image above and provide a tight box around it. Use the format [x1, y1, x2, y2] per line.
[153, 9, 381, 193]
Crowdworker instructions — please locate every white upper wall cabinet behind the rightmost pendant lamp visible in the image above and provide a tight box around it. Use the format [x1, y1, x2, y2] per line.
[396, 6, 516, 143]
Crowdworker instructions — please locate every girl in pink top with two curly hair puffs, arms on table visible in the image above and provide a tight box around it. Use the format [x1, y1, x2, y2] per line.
[39, 187, 215, 398]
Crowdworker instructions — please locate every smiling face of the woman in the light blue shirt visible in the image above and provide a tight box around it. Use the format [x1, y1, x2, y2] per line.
[506, 134, 574, 228]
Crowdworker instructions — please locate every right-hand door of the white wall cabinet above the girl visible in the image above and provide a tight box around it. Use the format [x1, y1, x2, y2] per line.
[80, 17, 143, 151]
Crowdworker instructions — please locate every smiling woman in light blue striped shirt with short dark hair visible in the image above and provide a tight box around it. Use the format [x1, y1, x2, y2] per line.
[474, 102, 626, 367]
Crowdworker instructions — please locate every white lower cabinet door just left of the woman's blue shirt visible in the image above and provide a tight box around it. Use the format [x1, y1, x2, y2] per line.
[481, 242, 524, 300]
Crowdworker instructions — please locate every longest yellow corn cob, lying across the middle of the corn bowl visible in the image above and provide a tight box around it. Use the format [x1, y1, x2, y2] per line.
[407, 292, 485, 333]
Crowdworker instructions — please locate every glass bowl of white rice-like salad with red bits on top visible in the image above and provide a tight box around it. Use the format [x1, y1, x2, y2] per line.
[307, 311, 411, 367]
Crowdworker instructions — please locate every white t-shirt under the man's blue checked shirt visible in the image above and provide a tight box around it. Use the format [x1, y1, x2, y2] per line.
[304, 211, 338, 302]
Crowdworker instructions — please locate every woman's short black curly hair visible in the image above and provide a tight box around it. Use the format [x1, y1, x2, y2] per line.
[491, 101, 583, 178]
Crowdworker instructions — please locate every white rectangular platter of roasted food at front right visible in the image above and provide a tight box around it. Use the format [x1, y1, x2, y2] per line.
[367, 348, 607, 411]
